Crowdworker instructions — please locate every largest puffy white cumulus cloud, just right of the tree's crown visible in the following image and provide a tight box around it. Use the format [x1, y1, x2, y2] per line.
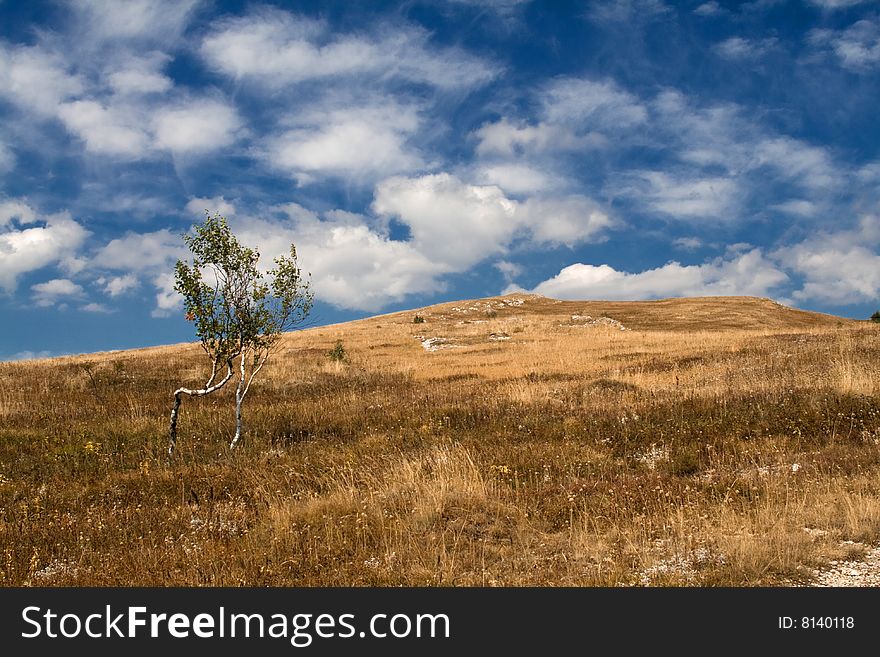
[185, 174, 613, 312]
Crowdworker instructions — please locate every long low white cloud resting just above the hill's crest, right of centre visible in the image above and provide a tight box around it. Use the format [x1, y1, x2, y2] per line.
[512, 249, 788, 300]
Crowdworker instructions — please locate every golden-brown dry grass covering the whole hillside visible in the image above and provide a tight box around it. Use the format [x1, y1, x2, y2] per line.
[0, 295, 880, 586]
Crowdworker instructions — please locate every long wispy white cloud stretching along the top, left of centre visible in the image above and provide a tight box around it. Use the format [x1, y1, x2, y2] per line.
[200, 9, 496, 88]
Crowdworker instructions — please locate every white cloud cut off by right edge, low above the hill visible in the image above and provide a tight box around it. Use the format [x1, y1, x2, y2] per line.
[774, 215, 880, 306]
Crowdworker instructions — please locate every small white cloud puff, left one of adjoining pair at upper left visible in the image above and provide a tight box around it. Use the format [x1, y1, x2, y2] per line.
[58, 100, 149, 157]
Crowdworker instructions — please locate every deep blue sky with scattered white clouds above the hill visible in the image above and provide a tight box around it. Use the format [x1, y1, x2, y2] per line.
[0, 0, 880, 358]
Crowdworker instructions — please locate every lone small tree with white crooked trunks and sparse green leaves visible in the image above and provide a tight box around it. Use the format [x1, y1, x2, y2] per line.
[168, 210, 312, 456]
